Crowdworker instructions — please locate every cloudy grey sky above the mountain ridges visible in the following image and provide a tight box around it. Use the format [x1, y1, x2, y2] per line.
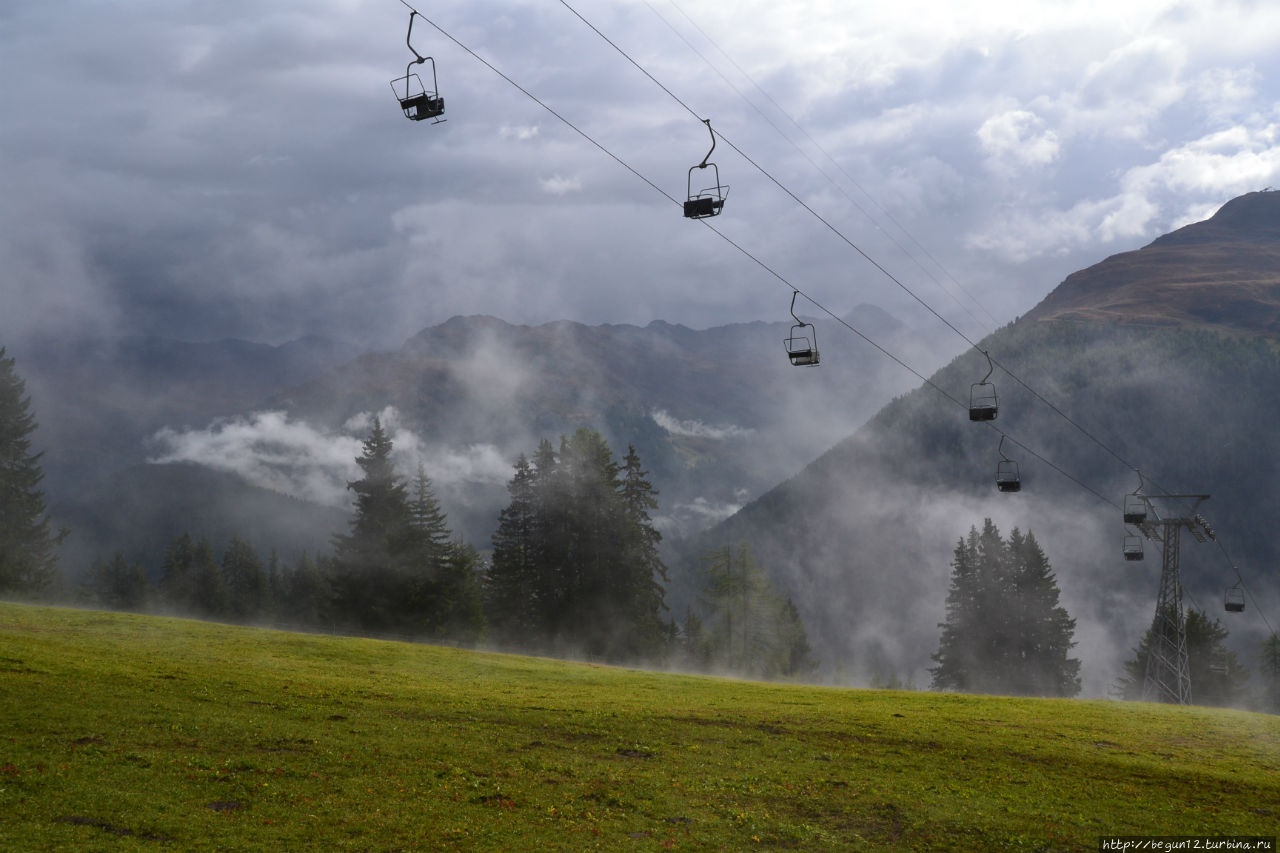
[0, 0, 1280, 351]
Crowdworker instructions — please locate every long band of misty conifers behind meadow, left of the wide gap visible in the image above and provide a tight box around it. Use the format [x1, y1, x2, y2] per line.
[0, 348, 812, 675]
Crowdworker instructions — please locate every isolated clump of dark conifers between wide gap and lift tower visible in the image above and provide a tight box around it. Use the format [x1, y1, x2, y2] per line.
[929, 519, 1080, 697]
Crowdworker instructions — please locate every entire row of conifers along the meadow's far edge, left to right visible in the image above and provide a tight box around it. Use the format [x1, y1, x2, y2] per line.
[0, 347, 1280, 696]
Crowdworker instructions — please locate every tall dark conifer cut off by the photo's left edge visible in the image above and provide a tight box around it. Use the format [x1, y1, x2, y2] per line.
[0, 347, 67, 596]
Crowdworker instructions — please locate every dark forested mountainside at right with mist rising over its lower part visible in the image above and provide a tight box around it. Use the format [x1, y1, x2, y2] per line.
[691, 193, 1280, 695]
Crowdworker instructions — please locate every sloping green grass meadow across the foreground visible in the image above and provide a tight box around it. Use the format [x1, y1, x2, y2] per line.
[0, 605, 1280, 850]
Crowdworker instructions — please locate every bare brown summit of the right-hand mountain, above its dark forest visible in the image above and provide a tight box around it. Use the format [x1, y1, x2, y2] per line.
[1027, 191, 1280, 337]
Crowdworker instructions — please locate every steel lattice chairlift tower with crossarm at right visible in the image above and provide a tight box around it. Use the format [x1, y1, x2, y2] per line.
[1124, 492, 1217, 704]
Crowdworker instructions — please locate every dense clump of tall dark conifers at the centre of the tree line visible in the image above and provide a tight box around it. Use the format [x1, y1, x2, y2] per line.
[485, 428, 672, 660]
